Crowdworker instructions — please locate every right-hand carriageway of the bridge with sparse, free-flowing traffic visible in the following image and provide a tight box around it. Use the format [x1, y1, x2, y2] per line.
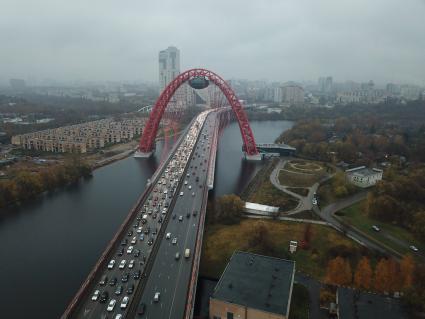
[127, 116, 215, 319]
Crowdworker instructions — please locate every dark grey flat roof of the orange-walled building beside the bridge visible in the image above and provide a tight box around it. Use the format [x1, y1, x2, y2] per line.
[212, 251, 295, 315]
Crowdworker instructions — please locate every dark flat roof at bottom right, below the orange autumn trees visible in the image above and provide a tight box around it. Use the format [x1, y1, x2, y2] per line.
[338, 288, 407, 319]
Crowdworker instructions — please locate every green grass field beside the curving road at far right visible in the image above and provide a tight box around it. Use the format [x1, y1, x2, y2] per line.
[337, 201, 425, 255]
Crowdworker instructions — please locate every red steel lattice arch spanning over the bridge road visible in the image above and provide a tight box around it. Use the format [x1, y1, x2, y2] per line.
[139, 69, 258, 155]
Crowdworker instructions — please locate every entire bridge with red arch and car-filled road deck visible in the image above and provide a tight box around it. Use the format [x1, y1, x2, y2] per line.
[62, 69, 261, 319]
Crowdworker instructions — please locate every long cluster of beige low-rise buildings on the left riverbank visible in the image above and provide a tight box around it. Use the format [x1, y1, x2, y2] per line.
[12, 118, 145, 153]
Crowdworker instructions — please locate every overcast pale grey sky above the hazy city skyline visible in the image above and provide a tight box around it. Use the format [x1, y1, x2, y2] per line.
[0, 0, 425, 85]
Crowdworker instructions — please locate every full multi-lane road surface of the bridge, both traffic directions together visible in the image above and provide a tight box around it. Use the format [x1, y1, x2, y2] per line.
[64, 111, 216, 319]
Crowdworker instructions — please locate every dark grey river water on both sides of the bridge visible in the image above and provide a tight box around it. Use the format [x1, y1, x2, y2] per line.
[0, 121, 292, 318]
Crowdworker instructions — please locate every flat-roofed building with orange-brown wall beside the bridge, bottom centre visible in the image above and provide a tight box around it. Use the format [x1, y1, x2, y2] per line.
[209, 251, 295, 319]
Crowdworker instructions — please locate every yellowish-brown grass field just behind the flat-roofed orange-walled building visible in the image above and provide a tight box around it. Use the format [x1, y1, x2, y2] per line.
[200, 219, 360, 279]
